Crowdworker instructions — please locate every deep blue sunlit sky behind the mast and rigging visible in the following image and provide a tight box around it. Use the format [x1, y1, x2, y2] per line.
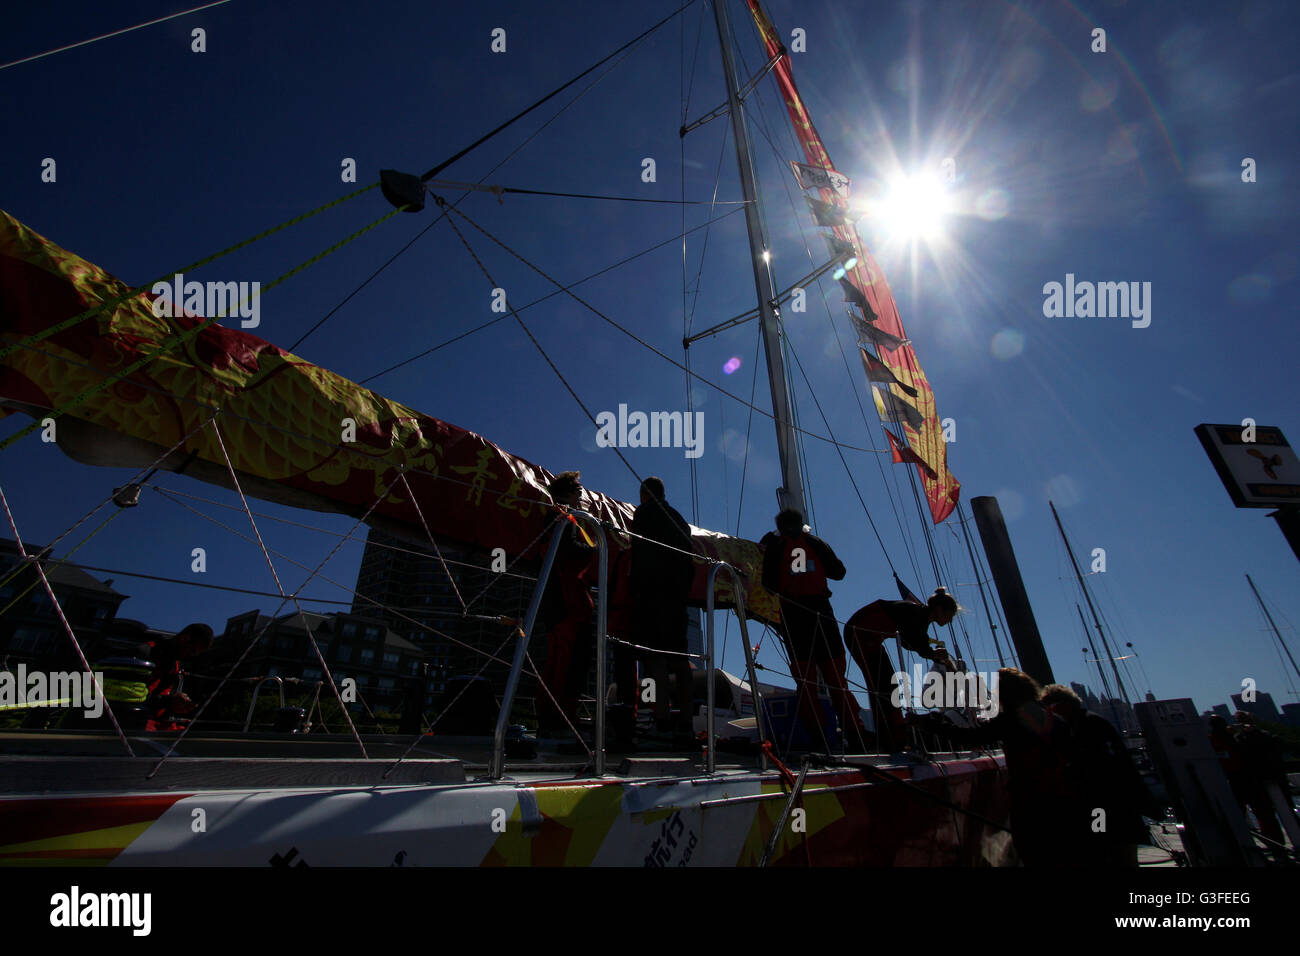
[0, 0, 1300, 709]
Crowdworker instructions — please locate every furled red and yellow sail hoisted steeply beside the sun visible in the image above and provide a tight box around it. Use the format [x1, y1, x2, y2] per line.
[748, 0, 961, 524]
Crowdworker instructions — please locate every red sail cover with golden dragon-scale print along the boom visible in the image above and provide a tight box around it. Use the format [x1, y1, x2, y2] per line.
[0, 211, 779, 622]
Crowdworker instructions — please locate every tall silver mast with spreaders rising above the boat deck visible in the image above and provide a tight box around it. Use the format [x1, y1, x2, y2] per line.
[714, 0, 807, 519]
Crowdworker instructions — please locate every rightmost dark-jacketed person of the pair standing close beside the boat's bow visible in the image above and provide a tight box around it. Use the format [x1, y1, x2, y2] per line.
[1040, 684, 1164, 866]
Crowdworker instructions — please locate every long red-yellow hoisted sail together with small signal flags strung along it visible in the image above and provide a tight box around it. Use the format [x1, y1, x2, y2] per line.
[746, 0, 961, 524]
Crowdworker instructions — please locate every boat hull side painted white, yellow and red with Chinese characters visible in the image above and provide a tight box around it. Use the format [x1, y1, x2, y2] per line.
[0, 756, 1010, 866]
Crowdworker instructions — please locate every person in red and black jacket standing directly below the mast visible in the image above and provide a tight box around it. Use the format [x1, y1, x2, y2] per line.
[761, 509, 874, 753]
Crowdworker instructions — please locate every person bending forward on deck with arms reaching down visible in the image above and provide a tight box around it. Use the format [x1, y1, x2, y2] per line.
[844, 588, 958, 750]
